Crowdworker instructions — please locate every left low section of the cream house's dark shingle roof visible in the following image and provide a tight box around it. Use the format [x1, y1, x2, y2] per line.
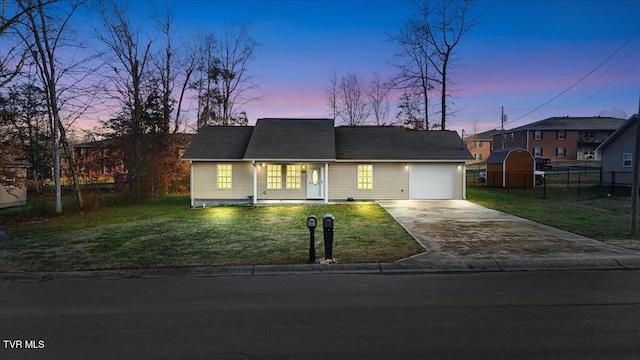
[182, 126, 254, 160]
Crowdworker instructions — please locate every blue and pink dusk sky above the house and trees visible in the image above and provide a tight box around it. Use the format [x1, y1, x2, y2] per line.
[80, 0, 640, 133]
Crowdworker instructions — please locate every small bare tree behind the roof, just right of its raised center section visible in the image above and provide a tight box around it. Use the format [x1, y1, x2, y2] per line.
[338, 72, 369, 126]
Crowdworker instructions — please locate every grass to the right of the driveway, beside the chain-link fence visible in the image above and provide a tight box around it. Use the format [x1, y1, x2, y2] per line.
[467, 185, 640, 250]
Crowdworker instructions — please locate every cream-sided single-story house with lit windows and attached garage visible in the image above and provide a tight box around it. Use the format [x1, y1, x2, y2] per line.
[183, 119, 472, 207]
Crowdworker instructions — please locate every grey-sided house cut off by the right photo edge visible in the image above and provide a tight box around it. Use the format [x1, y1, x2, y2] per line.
[596, 114, 638, 186]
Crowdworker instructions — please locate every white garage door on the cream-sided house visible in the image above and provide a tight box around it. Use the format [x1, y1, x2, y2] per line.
[409, 164, 456, 200]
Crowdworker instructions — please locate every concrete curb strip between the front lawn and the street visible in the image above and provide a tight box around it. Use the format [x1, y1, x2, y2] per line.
[0, 257, 640, 282]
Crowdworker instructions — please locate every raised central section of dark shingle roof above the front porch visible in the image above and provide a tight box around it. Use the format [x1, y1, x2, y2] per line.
[244, 119, 336, 160]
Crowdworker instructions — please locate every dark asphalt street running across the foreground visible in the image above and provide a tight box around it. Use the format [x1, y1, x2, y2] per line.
[0, 270, 640, 359]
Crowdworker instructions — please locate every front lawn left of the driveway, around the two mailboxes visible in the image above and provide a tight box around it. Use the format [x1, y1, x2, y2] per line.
[0, 196, 423, 272]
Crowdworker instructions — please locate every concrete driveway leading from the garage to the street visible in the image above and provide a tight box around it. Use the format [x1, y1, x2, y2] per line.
[378, 200, 640, 261]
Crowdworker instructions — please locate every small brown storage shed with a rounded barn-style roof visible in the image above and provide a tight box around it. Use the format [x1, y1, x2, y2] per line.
[487, 147, 536, 188]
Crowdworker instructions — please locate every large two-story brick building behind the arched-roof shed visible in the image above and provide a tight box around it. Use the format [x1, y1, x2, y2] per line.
[493, 116, 624, 162]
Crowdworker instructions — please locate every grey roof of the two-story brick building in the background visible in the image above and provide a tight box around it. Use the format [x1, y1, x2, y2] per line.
[508, 116, 624, 132]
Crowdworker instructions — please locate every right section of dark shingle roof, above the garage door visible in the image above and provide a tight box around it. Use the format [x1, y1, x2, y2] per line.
[336, 126, 473, 161]
